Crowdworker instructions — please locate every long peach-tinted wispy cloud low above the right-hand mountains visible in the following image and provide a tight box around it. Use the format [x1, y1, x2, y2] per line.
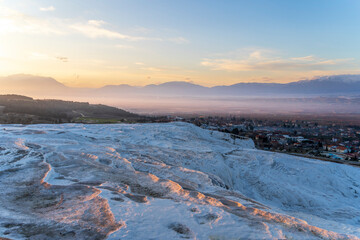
[201, 50, 353, 72]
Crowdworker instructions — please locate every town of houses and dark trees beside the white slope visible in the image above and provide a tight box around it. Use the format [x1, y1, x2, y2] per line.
[186, 117, 360, 161]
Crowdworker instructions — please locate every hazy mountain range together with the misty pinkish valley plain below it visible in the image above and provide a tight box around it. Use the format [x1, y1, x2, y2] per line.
[0, 75, 360, 114]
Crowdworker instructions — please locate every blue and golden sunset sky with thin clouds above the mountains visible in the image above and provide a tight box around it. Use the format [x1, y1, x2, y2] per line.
[0, 0, 360, 87]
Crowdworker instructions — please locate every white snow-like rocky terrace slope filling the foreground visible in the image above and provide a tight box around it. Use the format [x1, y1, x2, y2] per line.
[0, 123, 360, 239]
